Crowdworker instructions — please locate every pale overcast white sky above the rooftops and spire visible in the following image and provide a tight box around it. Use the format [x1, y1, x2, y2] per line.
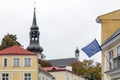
[0, 0, 120, 62]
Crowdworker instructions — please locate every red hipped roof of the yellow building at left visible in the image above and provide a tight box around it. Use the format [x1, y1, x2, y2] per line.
[0, 45, 36, 55]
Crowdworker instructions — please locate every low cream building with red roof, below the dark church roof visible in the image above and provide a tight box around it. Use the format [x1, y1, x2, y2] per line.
[44, 67, 87, 80]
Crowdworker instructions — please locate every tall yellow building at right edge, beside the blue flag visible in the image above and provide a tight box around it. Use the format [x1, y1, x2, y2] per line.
[97, 10, 120, 80]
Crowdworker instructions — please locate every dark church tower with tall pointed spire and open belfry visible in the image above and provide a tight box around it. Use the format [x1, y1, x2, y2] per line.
[27, 8, 45, 59]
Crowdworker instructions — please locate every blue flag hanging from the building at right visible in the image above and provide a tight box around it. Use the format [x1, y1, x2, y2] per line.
[81, 39, 102, 57]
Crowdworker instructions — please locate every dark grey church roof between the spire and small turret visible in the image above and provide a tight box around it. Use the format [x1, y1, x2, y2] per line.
[48, 58, 78, 67]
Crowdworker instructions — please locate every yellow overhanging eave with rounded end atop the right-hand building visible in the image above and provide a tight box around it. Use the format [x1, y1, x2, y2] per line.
[96, 9, 120, 23]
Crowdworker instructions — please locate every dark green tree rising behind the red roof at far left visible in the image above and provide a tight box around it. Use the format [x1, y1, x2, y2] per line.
[0, 34, 21, 50]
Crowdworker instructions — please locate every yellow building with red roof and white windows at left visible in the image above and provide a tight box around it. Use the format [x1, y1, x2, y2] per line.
[0, 46, 38, 80]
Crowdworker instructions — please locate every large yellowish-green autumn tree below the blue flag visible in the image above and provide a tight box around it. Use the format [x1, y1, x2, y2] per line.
[71, 60, 101, 80]
